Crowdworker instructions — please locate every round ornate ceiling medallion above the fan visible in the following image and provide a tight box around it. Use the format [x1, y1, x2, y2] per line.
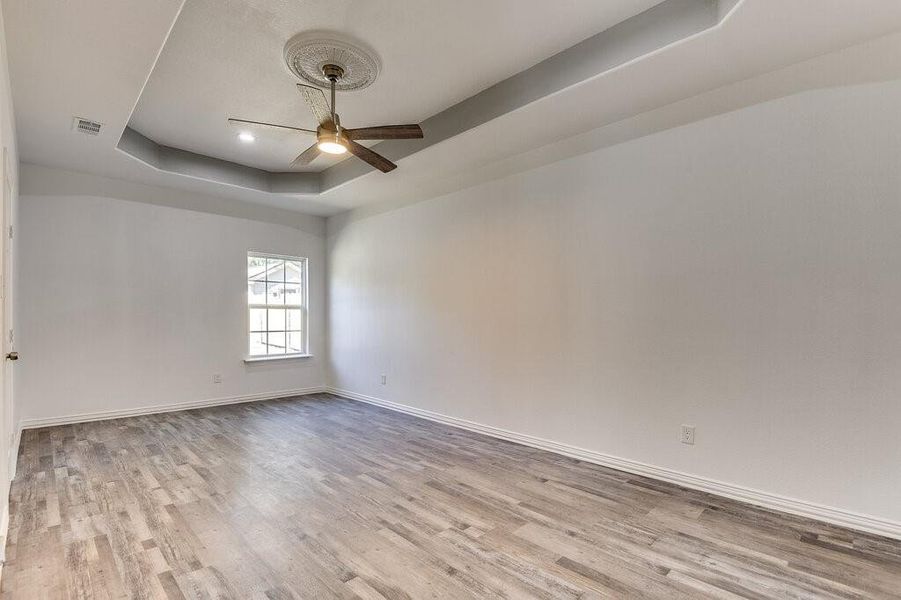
[285, 33, 380, 92]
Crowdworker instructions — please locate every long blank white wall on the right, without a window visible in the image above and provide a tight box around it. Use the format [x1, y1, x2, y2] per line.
[329, 77, 901, 523]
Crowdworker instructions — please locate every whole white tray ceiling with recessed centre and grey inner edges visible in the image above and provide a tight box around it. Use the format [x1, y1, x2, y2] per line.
[2, 0, 901, 215]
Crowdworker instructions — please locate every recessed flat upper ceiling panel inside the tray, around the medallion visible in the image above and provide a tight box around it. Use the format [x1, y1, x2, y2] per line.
[130, 0, 660, 171]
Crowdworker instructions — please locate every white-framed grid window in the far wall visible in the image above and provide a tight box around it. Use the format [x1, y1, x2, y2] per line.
[247, 252, 308, 358]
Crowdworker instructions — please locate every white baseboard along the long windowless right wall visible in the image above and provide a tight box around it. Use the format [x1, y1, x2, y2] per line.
[328, 387, 901, 540]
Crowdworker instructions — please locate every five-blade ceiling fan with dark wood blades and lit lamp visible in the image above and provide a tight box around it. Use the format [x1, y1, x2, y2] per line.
[228, 64, 423, 173]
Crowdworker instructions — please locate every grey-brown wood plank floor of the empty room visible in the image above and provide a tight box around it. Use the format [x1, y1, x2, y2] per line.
[2, 395, 901, 600]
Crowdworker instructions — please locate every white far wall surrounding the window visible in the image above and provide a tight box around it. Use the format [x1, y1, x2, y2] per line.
[16, 165, 326, 423]
